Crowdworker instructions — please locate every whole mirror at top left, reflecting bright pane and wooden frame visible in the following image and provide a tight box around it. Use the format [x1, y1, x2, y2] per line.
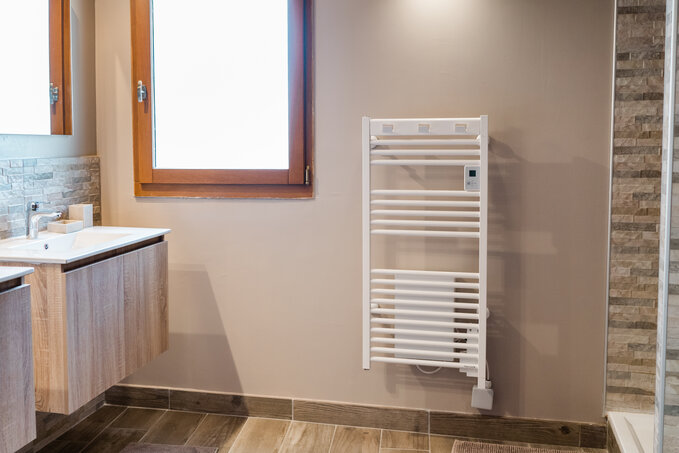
[0, 0, 72, 135]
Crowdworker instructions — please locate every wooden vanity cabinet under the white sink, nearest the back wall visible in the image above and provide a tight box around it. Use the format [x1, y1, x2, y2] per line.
[7, 237, 169, 414]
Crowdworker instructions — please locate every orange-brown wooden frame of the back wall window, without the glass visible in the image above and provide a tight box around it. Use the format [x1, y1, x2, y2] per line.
[130, 0, 313, 198]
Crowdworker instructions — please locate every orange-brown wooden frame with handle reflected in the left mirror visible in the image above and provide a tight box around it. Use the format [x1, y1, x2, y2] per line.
[45, 0, 73, 135]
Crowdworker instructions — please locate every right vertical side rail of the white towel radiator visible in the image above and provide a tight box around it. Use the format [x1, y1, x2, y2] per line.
[477, 115, 488, 389]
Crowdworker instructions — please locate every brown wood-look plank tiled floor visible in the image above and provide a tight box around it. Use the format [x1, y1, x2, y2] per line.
[35, 406, 604, 453]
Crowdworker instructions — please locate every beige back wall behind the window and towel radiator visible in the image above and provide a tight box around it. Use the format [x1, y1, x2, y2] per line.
[96, 0, 614, 421]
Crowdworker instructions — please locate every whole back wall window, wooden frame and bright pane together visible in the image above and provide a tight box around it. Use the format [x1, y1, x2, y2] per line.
[131, 0, 313, 198]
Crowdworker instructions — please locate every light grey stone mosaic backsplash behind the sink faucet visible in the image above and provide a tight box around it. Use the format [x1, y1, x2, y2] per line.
[0, 156, 101, 239]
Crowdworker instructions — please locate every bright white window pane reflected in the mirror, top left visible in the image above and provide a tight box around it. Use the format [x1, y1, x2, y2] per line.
[0, 0, 51, 135]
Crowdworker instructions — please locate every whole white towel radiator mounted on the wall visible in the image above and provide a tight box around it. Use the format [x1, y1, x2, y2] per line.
[363, 116, 493, 409]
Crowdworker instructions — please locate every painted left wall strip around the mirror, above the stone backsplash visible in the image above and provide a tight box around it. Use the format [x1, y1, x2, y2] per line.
[0, 0, 97, 159]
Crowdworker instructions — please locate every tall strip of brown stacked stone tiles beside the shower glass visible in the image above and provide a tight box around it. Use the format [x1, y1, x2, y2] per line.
[606, 0, 665, 411]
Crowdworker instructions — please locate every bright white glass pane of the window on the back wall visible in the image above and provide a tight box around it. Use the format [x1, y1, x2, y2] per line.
[153, 0, 288, 169]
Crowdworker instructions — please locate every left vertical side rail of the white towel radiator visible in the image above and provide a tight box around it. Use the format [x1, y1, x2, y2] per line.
[361, 117, 371, 370]
